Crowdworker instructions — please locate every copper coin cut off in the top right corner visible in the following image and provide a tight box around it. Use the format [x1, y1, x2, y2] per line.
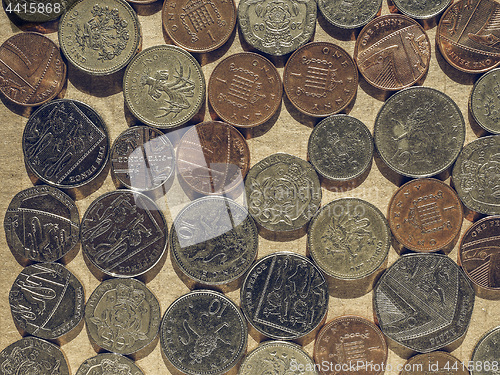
[436, 0, 500, 73]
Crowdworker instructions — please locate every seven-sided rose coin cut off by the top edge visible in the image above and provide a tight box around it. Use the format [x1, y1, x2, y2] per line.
[238, 0, 316, 56]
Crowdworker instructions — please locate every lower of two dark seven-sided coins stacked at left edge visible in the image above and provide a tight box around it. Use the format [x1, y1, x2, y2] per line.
[9, 263, 85, 340]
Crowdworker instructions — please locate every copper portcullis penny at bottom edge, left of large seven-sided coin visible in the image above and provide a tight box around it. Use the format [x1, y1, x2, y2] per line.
[314, 316, 387, 375]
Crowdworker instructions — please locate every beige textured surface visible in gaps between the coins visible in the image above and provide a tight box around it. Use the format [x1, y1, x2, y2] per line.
[0, 2, 500, 375]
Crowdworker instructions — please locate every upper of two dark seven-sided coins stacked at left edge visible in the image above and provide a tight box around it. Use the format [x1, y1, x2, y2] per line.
[3, 185, 80, 266]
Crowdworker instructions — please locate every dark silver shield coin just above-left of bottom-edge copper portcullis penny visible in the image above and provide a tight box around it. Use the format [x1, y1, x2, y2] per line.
[240, 252, 328, 340]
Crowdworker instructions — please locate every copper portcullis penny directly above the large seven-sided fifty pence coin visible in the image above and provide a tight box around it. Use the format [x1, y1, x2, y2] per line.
[387, 178, 463, 253]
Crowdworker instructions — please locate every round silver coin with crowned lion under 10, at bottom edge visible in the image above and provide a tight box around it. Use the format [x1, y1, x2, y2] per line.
[160, 289, 248, 375]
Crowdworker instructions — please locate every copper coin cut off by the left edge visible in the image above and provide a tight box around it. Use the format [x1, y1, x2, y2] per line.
[0, 32, 66, 106]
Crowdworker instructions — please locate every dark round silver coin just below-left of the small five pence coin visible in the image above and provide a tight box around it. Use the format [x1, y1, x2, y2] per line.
[80, 190, 168, 277]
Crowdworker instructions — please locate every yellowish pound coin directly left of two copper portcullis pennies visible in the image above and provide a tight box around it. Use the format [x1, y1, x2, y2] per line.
[123, 45, 205, 129]
